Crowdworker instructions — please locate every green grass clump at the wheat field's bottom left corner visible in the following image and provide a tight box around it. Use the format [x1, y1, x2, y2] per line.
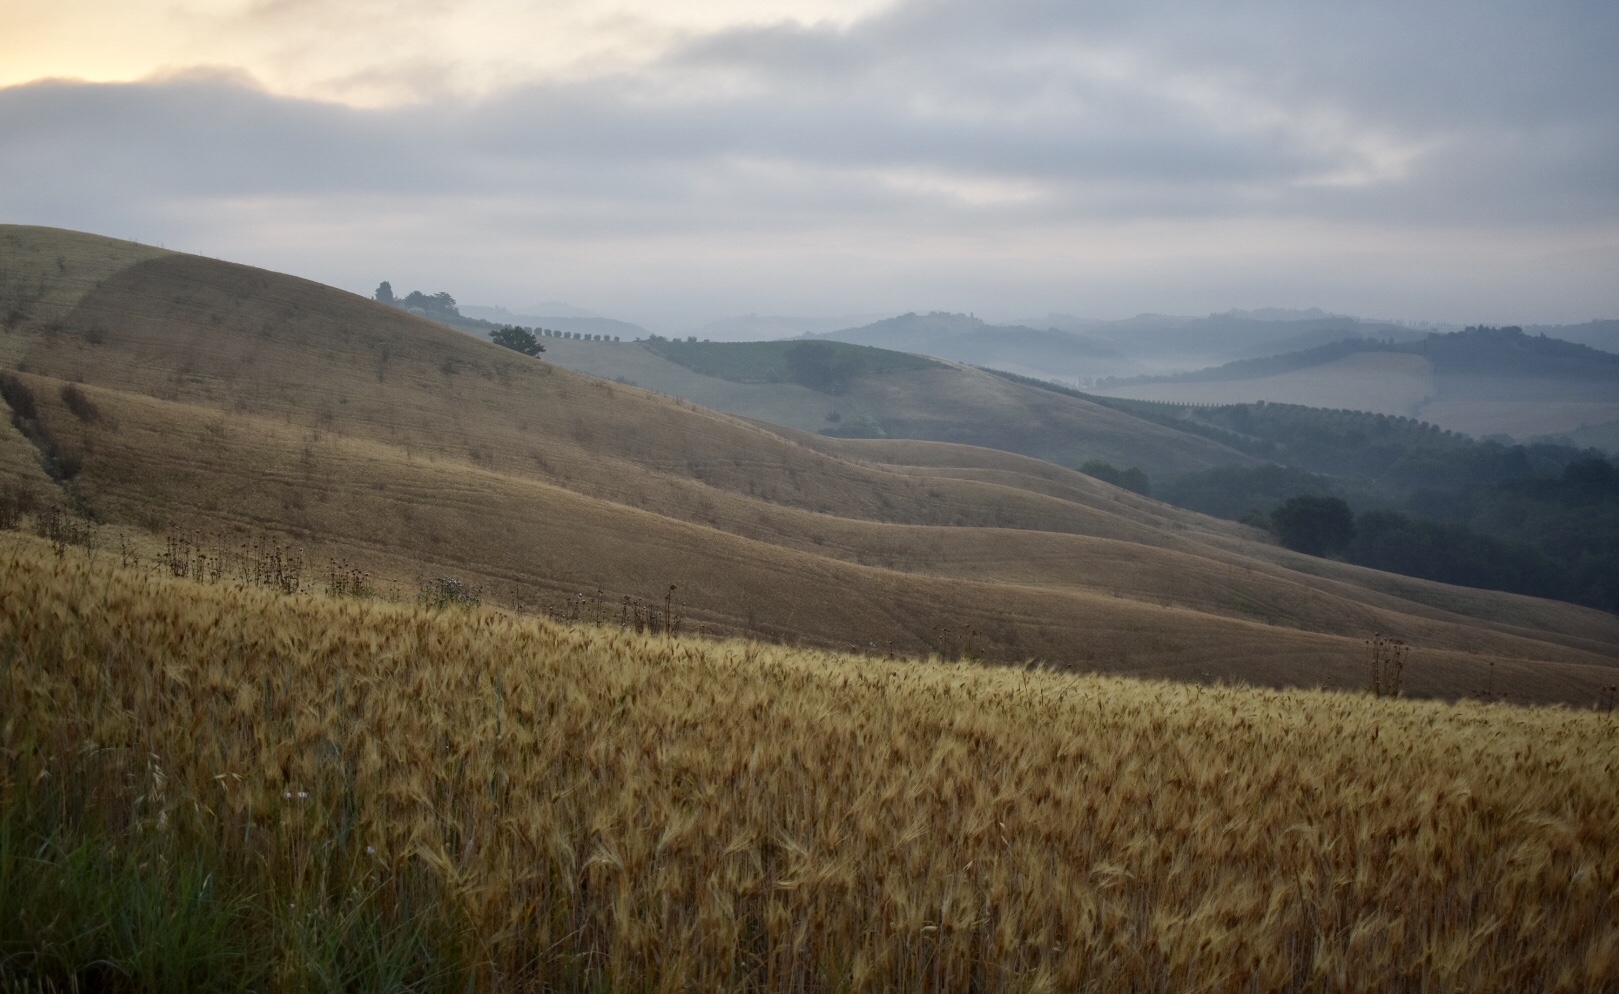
[0, 754, 466, 994]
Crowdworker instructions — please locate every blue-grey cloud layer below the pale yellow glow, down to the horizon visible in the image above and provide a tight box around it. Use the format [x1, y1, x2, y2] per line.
[0, 0, 1619, 317]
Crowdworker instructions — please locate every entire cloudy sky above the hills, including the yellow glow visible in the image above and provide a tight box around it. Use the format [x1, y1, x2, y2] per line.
[0, 0, 1619, 330]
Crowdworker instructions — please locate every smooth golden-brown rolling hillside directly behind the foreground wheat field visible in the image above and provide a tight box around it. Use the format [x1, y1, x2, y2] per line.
[0, 227, 1619, 704]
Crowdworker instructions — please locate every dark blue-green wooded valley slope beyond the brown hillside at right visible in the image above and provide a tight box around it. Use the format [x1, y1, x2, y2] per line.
[997, 370, 1619, 610]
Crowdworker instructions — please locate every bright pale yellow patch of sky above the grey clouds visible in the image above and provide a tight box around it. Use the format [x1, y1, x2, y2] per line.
[0, 0, 887, 107]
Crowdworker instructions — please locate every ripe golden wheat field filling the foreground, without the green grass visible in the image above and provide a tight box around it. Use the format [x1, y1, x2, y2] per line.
[9, 537, 1619, 991]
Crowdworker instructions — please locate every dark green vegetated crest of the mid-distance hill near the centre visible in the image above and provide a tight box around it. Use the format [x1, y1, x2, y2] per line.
[646, 335, 944, 393]
